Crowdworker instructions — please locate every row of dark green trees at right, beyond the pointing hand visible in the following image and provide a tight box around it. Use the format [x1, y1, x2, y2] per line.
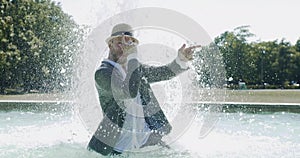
[215, 26, 300, 88]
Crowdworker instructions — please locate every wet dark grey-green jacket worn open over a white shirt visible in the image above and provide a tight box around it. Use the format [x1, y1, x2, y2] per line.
[88, 59, 186, 155]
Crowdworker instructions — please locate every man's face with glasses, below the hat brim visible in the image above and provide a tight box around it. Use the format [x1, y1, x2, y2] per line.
[108, 36, 135, 64]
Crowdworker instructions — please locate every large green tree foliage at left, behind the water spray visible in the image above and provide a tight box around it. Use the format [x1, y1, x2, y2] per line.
[0, 0, 82, 93]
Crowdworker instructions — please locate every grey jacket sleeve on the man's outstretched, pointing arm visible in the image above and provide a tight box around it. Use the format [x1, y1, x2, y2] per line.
[142, 57, 188, 83]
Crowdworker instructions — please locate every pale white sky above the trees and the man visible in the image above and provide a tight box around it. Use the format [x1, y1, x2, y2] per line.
[56, 0, 300, 44]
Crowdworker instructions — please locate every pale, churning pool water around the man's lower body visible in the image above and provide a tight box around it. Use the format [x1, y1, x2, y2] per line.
[0, 103, 300, 158]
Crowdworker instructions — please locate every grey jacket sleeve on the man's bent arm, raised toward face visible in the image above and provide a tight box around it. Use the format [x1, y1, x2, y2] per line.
[95, 59, 140, 100]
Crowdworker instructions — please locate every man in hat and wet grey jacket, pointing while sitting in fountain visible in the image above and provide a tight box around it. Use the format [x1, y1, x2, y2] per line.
[88, 23, 200, 155]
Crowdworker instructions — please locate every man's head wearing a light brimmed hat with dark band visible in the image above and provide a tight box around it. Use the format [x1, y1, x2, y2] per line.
[106, 23, 138, 64]
